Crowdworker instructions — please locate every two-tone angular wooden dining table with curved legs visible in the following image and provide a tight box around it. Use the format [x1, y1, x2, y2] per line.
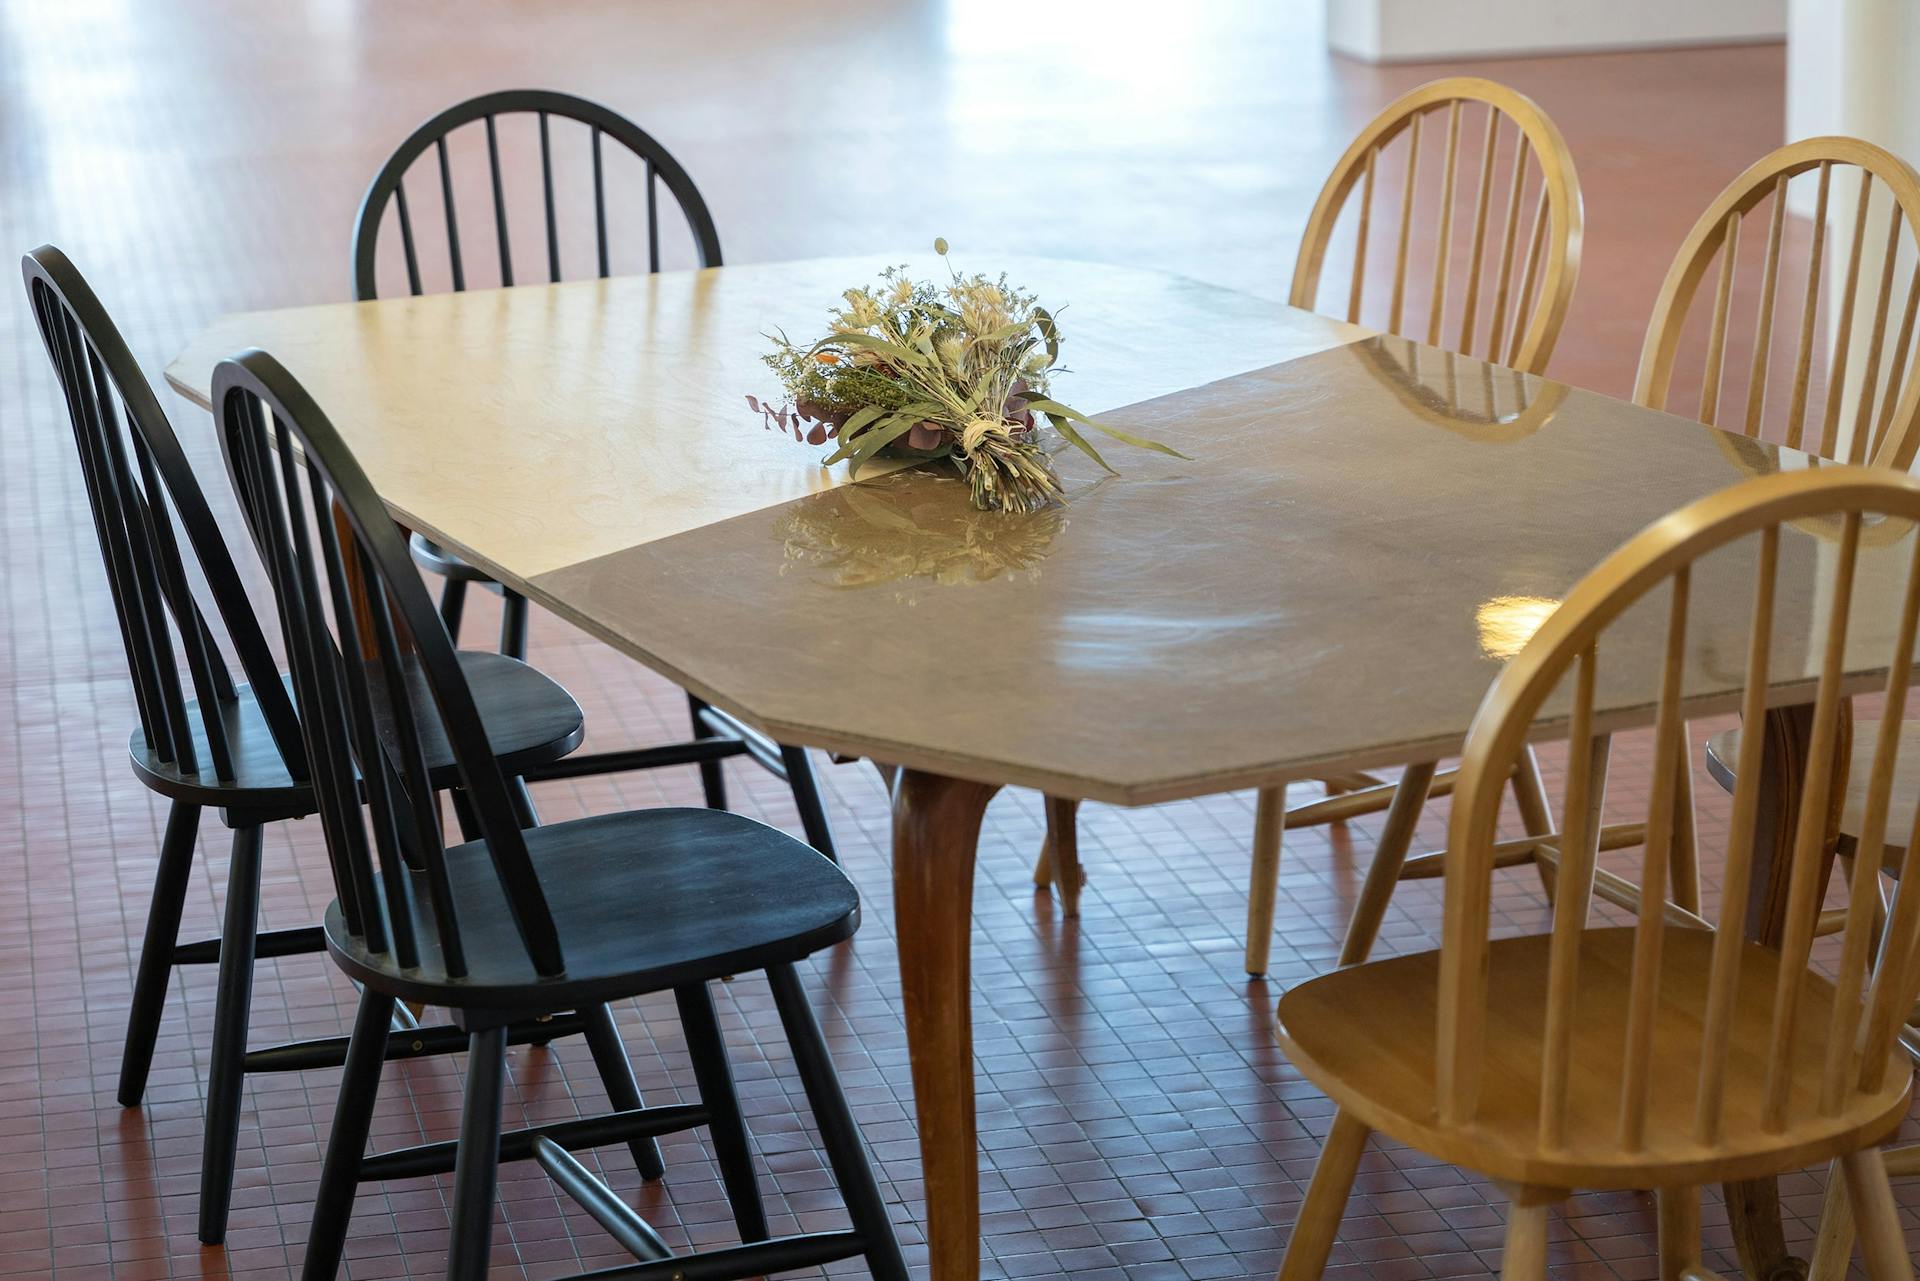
[167, 255, 1885, 1281]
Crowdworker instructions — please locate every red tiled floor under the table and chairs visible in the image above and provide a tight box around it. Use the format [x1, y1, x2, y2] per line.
[0, 0, 1910, 1281]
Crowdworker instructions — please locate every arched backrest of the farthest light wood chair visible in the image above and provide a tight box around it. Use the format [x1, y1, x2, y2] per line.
[1288, 77, 1584, 373]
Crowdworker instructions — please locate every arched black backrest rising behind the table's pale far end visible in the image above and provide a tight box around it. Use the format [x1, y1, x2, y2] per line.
[353, 88, 720, 302]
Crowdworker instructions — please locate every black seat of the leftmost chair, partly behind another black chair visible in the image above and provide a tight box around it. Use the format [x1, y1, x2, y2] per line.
[127, 649, 586, 822]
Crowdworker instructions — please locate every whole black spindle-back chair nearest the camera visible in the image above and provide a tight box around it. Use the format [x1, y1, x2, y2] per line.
[213, 351, 906, 1281]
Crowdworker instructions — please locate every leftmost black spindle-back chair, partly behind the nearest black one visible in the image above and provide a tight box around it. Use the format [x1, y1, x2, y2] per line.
[21, 246, 660, 1245]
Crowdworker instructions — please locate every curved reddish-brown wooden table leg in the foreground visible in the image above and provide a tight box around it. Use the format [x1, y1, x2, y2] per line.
[893, 770, 998, 1281]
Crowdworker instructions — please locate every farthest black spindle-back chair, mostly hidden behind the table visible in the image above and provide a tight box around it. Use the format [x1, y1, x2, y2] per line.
[353, 88, 833, 858]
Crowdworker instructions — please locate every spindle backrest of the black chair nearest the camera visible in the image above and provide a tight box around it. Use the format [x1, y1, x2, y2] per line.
[213, 351, 564, 976]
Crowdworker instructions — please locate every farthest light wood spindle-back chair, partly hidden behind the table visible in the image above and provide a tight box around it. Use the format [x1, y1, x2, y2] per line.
[1033, 77, 1584, 976]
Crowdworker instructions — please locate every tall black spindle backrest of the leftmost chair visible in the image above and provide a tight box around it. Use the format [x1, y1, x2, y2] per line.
[21, 244, 307, 782]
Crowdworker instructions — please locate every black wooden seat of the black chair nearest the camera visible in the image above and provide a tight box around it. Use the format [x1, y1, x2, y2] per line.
[326, 809, 860, 1010]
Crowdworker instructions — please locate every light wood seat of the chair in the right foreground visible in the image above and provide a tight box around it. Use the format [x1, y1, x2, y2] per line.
[1279, 926, 1912, 1189]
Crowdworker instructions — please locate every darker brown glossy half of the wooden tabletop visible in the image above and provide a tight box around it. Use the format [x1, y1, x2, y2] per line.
[533, 338, 1905, 805]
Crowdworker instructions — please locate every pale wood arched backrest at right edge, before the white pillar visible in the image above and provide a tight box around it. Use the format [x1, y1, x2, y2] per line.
[1634, 138, 1920, 469]
